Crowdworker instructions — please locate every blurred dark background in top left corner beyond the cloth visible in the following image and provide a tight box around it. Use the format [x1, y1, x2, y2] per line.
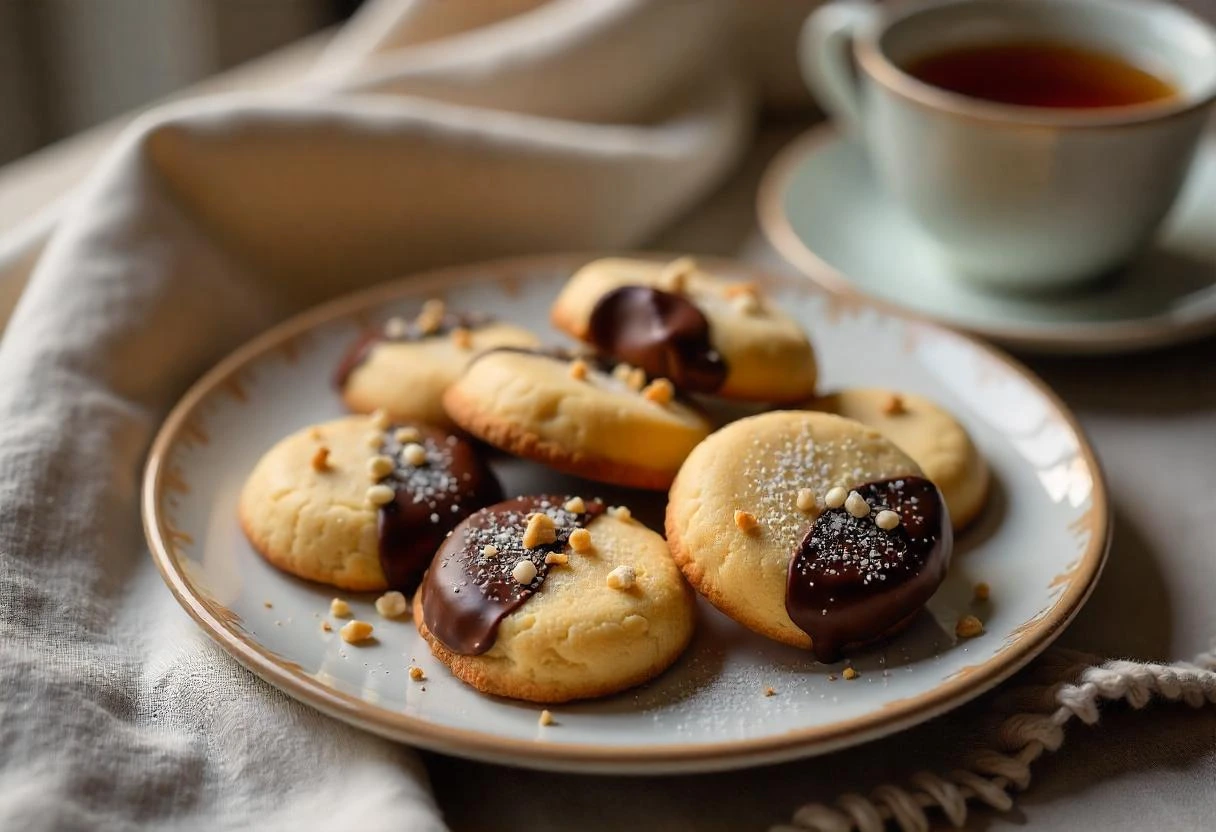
[0, 0, 359, 164]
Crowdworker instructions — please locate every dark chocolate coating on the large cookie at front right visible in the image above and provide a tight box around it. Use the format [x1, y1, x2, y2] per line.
[786, 477, 953, 662]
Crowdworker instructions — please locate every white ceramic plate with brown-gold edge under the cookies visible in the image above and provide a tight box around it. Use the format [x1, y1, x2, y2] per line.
[143, 255, 1108, 772]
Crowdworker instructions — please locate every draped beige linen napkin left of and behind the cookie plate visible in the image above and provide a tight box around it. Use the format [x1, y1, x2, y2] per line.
[0, 0, 750, 831]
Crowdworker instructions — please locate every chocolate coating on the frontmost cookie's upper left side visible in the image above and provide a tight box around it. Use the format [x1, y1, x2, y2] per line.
[421, 495, 604, 656]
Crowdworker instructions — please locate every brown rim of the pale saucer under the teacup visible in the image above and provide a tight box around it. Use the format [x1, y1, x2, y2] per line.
[756, 122, 1216, 355]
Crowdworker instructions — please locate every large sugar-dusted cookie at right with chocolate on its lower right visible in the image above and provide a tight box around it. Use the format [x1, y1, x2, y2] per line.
[666, 411, 953, 662]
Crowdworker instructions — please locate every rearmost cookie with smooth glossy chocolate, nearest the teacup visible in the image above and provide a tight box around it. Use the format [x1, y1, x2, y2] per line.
[551, 258, 816, 403]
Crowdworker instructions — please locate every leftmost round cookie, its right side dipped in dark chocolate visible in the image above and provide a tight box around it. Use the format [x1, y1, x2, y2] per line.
[238, 414, 502, 594]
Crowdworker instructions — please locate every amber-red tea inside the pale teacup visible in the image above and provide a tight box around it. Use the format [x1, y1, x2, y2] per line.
[907, 43, 1175, 109]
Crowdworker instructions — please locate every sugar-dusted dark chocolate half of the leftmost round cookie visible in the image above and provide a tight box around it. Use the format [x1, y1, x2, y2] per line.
[379, 425, 502, 595]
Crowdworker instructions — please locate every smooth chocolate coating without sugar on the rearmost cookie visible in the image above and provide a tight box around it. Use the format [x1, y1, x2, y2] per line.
[587, 286, 727, 393]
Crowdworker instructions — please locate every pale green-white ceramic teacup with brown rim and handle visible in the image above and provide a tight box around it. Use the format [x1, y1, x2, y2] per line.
[800, 0, 1216, 289]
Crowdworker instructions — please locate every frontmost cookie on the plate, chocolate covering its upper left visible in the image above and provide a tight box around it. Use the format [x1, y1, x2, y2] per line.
[413, 495, 693, 702]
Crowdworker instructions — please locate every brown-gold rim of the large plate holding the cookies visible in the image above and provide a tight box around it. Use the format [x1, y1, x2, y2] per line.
[141, 252, 1111, 774]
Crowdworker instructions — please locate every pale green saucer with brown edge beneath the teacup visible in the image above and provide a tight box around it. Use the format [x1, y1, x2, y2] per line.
[759, 125, 1216, 353]
